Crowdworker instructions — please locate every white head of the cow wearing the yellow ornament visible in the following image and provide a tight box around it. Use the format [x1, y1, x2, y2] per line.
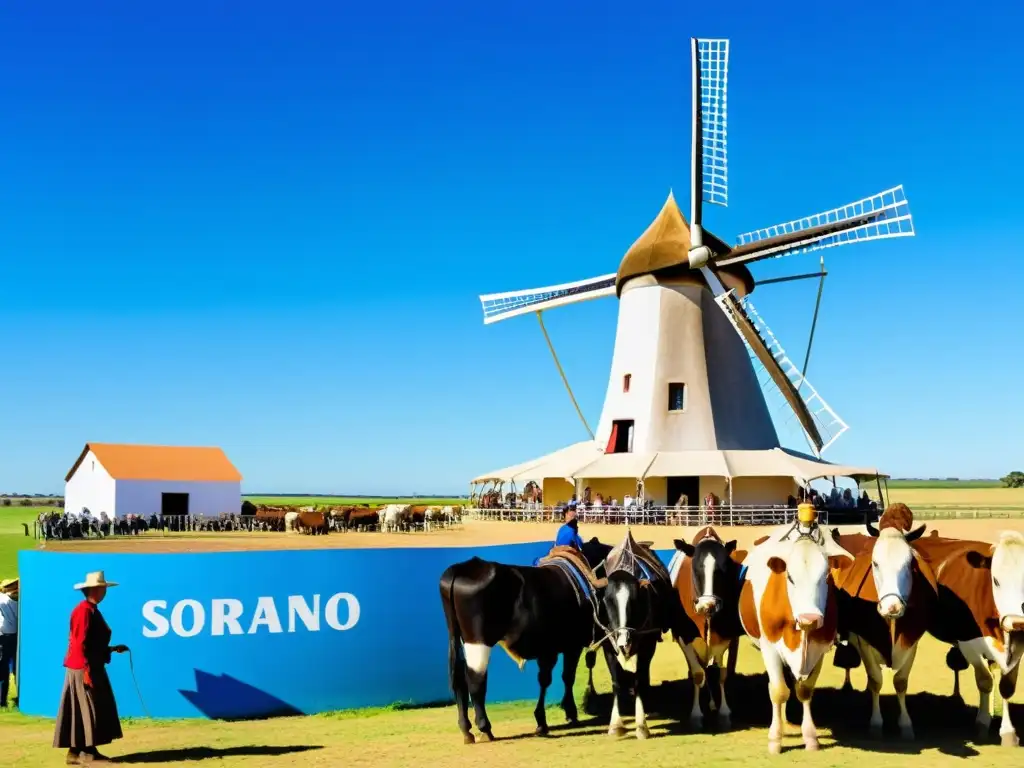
[768, 537, 853, 632]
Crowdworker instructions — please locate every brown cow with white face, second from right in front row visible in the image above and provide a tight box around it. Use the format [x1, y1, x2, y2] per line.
[833, 524, 938, 739]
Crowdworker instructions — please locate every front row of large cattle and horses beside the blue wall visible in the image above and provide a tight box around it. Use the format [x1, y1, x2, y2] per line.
[440, 504, 1024, 754]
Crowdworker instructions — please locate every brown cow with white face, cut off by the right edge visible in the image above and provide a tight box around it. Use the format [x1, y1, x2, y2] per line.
[916, 530, 1024, 746]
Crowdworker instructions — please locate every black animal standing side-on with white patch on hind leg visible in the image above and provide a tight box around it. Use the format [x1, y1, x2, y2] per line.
[440, 539, 611, 743]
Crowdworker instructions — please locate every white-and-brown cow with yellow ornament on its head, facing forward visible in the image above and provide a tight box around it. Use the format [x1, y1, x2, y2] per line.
[739, 522, 853, 755]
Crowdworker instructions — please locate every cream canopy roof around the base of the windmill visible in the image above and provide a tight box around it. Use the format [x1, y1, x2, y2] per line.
[473, 440, 887, 484]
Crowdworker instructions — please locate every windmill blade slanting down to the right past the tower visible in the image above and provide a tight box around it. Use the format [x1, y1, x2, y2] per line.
[715, 291, 848, 456]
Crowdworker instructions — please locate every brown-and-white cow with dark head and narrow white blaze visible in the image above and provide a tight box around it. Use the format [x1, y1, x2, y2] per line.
[669, 526, 746, 728]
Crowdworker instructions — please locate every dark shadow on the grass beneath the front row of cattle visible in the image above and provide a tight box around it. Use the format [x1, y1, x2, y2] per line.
[581, 668, 1021, 757]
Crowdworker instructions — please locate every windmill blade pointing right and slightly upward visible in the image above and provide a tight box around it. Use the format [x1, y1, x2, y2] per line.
[713, 184, 913, 266]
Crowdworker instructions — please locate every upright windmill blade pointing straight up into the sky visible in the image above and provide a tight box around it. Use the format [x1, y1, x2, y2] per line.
[690, 38, 729, 236]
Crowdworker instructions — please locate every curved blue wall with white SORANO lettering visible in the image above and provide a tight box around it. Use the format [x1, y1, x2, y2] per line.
[18, 542, 585, 718]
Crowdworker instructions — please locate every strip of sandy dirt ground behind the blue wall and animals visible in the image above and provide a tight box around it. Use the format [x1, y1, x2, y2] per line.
[41, 520, 1024, 553]
